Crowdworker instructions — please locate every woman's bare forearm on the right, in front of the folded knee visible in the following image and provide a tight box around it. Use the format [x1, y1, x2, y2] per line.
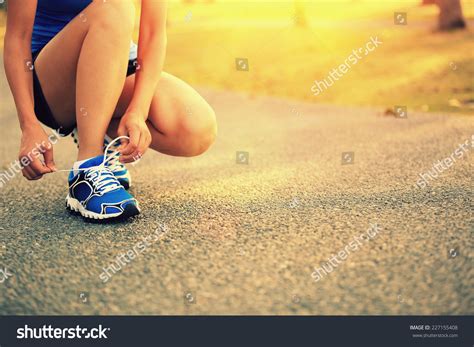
[128, 0, 167, 119]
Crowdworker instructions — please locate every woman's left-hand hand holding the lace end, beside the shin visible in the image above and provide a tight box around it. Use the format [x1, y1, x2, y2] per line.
[18, 123, 56, 180]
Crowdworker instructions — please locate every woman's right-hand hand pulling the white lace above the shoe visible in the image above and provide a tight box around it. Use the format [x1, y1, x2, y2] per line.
[117, 111, 151, 163]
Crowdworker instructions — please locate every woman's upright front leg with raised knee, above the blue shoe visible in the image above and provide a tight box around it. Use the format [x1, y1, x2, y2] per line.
[35, 0, 135, 160]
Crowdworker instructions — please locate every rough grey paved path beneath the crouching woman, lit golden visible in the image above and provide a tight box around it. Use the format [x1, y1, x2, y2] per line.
[0, 78, 474, 314]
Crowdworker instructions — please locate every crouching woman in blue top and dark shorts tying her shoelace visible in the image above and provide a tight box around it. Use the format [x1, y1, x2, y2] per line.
[4, 0, 216, 221]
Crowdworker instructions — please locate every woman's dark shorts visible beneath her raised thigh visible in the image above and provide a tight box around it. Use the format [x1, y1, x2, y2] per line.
[32, 51, 137, 136]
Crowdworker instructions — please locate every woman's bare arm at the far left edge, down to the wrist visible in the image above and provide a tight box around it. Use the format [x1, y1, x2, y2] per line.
[3, 0, 39, 129]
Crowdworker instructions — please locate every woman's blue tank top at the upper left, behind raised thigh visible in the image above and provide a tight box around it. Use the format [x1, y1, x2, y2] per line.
[31, 0, 137, 59]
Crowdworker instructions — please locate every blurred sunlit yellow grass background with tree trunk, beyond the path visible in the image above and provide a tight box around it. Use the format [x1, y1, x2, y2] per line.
[0, 0, 474, 113]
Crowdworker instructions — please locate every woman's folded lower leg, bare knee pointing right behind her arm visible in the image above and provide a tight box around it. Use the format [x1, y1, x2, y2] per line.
[107, 72, 217, 157]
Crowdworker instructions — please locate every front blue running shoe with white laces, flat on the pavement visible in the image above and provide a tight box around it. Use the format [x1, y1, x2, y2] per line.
[66, 155, 140, 221]
